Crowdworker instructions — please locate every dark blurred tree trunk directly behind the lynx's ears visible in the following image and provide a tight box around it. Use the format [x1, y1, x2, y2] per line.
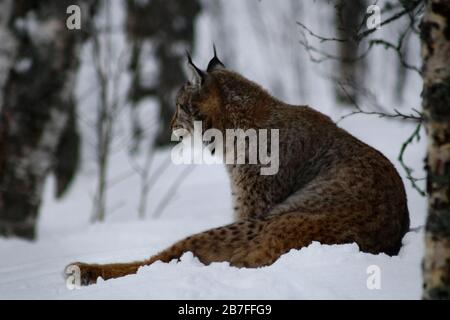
[126, 0, 200, 151]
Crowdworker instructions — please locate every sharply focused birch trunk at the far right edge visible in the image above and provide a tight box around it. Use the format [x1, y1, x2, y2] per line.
[421, 0, 450, 299]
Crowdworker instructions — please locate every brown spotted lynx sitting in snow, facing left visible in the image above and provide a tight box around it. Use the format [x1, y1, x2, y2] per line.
[67, 50, 409, 285]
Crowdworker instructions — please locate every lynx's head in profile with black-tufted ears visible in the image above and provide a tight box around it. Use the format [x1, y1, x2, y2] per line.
[171, 48, 225, 133]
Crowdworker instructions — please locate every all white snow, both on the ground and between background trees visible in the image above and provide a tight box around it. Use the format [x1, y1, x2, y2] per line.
[0, 1, 426, 299]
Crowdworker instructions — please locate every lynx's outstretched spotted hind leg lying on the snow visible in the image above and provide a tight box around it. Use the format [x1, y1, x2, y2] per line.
[66, 213, 374, 285]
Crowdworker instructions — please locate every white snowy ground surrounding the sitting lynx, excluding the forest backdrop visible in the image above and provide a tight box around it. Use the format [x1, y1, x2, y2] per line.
[0, 111, 425, 299]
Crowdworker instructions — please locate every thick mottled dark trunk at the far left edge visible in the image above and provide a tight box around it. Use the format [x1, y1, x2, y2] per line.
[0, 0, 94, 239]
